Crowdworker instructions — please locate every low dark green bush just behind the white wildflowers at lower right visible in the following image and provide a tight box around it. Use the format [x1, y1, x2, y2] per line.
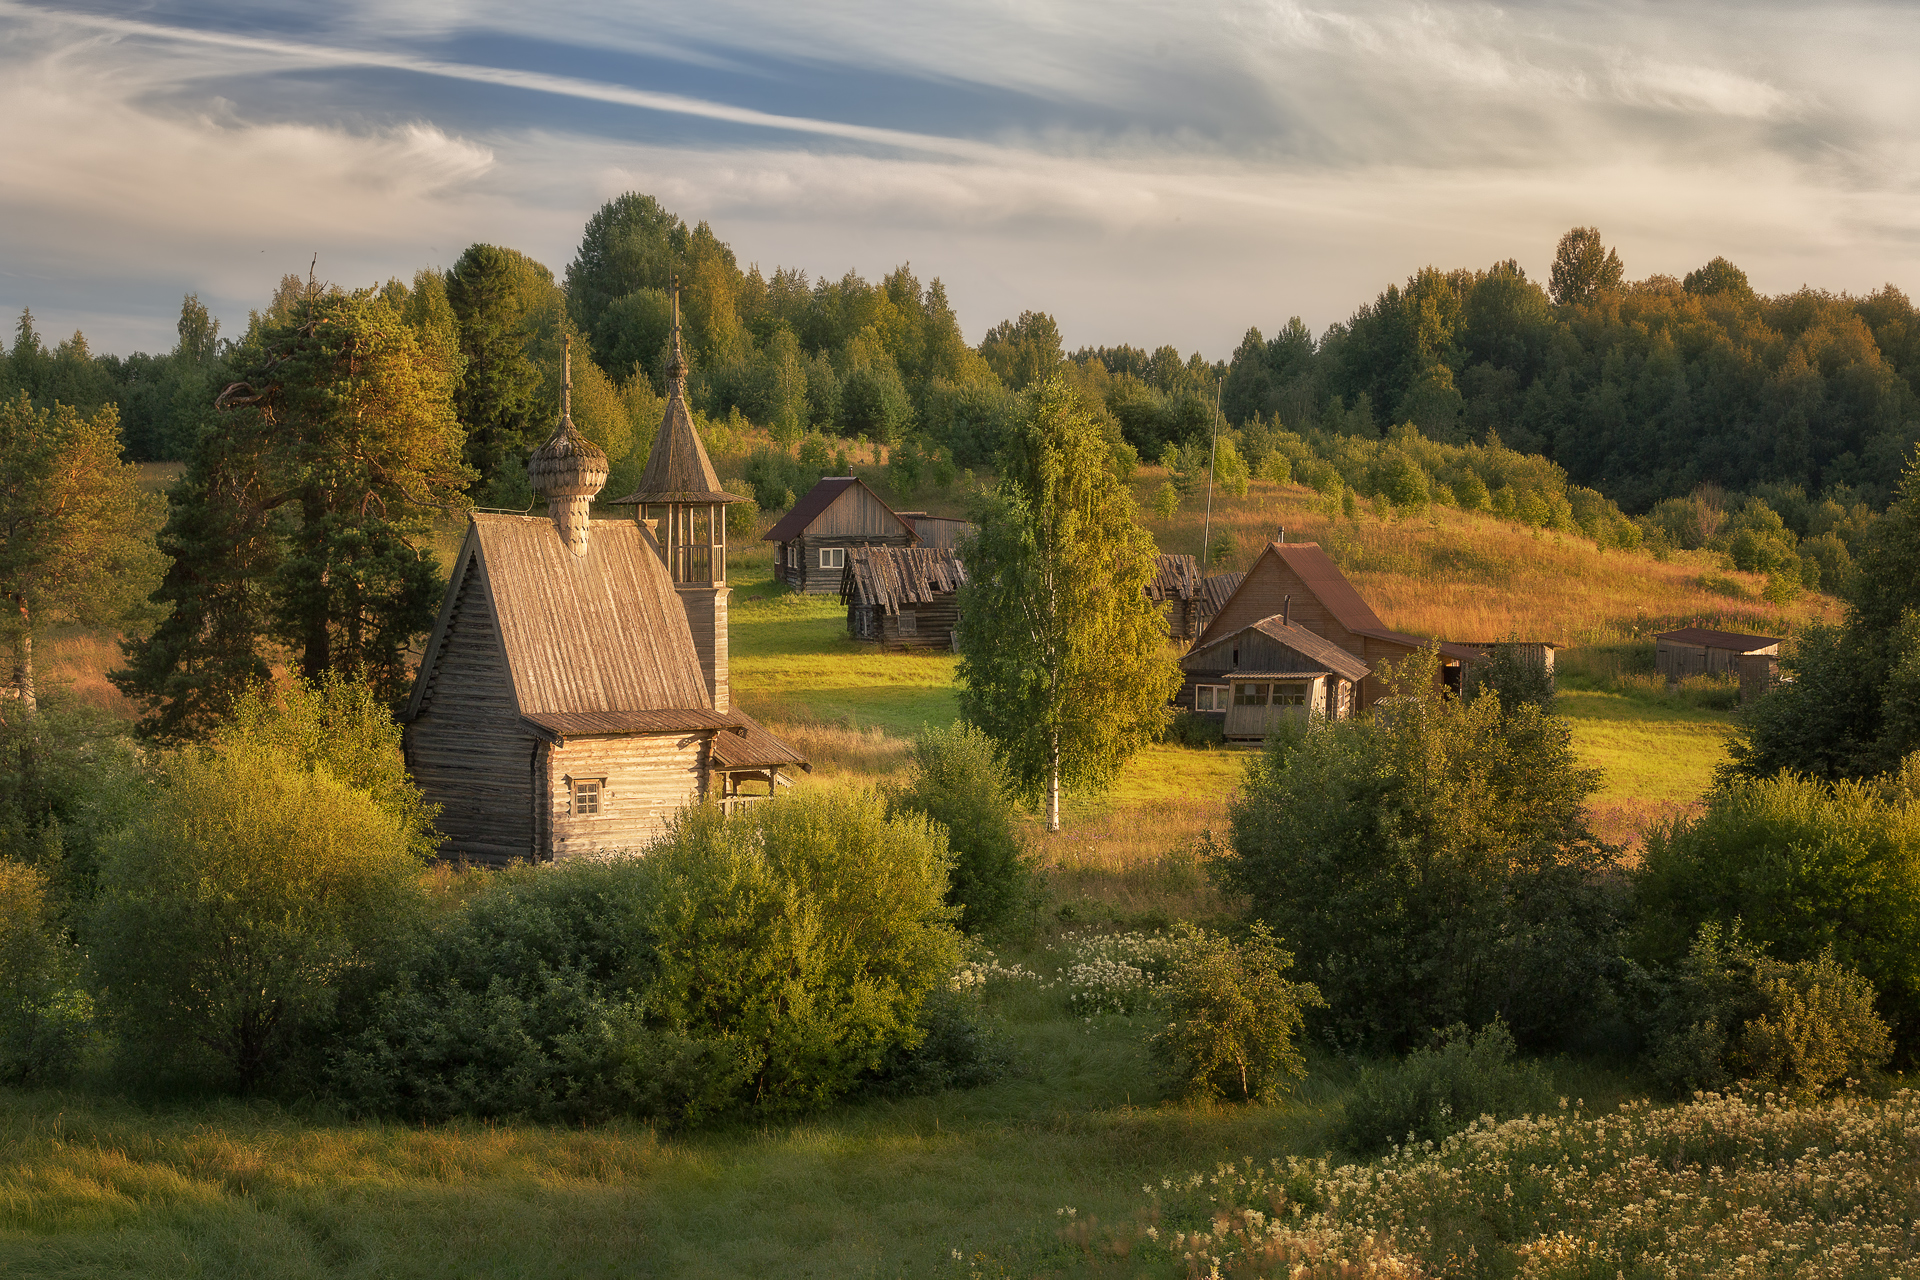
[1336, 1019, 1553, 1155]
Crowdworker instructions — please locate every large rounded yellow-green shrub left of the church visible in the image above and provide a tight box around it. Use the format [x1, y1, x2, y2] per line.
[88, 743, 420, 1088]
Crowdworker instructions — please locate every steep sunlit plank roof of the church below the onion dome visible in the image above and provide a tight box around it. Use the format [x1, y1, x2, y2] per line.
[449, 514, 712, 716]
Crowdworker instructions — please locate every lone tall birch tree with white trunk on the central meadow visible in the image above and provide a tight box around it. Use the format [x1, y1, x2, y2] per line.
[960, 378, 1181, 831]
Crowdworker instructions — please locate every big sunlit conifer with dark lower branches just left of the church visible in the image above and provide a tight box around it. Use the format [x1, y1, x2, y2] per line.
[115, 286, 474, 737]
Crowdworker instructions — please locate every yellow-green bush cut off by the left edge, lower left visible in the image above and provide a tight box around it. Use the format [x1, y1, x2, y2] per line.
[0, 858, 92, 1084]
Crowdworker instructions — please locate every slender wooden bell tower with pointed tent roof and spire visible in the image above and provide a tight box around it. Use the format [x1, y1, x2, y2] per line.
[618, 276, 743, 712]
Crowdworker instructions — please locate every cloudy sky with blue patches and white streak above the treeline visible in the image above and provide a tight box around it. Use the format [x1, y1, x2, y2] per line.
[0, 0, 1920, 357]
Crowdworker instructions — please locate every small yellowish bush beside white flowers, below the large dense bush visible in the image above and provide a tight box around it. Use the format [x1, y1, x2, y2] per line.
[1154, 925, 1325, 1102]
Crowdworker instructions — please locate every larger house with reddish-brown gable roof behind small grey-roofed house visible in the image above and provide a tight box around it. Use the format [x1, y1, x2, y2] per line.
[1192, 543, 1484, 710]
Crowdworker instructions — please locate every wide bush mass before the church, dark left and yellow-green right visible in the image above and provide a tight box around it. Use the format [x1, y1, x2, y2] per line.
[330, 789, 958, 1123]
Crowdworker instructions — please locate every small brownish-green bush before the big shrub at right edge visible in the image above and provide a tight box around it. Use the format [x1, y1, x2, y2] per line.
[1647, 923, 1893, 1098]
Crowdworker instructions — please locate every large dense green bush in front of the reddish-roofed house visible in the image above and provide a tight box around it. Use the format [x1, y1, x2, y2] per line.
[1219, 649, 1619, 1052]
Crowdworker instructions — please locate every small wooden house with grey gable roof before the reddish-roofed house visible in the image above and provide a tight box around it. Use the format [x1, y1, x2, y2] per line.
[1179, 614, 1371, 741]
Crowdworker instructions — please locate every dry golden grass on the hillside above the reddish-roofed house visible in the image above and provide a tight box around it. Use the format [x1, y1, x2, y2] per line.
[1135, 466, 1839, 645]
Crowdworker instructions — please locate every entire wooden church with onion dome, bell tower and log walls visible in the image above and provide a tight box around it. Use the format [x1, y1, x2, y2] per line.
[403, 301, 806, 865]
